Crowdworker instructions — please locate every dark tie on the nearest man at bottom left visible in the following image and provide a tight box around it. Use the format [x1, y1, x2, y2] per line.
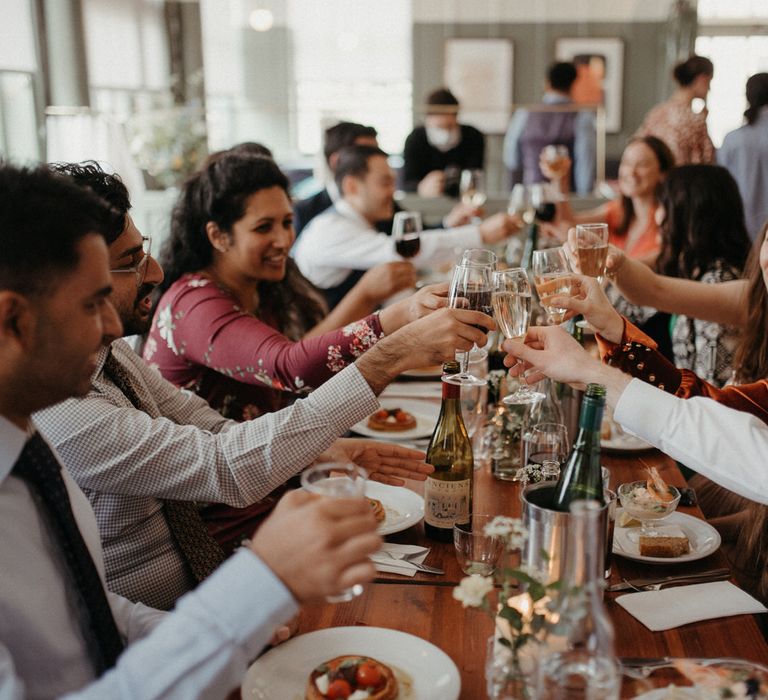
[12, 433, 123, 675]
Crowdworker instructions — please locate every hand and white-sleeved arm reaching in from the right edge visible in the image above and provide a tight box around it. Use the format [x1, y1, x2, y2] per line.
[503, 326, 768, 504]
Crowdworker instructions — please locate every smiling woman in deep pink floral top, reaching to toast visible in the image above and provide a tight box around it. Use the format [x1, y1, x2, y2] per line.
[144, 153, 432, 420]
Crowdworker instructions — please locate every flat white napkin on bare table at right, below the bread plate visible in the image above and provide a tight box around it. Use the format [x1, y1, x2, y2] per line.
[616, 581, 767, 632]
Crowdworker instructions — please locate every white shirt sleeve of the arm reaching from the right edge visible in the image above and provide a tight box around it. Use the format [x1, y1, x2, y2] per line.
[613, 379, 768, 504]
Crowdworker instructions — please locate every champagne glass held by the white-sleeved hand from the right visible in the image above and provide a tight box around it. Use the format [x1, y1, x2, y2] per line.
[492, 267, 544, 404]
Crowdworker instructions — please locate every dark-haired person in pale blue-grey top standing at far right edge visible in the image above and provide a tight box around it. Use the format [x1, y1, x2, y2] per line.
[717, 73, 768, 240]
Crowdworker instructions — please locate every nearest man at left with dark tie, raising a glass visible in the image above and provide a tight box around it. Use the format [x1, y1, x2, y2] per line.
[0, 165, 380, 700]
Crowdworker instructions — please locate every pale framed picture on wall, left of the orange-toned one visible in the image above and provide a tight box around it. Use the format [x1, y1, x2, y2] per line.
[443, 39, 513, 134]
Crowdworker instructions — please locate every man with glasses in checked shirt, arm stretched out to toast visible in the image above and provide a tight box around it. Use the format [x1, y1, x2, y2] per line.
[36, 164, 492, 609]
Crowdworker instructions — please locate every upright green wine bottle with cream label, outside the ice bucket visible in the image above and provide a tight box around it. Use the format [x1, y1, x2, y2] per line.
[424, 361, 474, 542]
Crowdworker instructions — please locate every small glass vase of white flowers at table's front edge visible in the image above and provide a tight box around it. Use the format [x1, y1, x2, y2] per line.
[453, 516, 560, 700]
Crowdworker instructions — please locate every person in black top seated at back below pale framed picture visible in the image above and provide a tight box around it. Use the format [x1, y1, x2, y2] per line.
[402, 88, 485, 197]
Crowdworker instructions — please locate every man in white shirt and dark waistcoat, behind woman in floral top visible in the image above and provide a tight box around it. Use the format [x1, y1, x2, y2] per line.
[292, 146, 520, 306]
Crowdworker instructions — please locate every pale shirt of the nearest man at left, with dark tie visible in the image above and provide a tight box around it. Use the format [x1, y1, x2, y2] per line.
[0, 416, 297, 700]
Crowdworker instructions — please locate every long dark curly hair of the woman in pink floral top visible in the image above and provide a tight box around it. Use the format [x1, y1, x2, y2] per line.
[160, 152, 327, 340]
